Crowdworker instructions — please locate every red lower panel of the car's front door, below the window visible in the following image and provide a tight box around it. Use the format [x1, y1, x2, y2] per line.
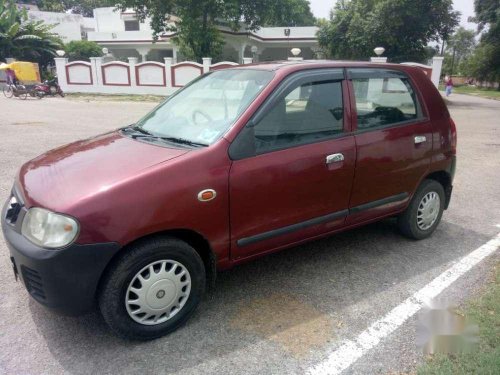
[229, 136, 355, 259]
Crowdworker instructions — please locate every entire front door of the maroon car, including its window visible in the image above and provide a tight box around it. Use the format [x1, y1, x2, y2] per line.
[229, 69, 355, 259]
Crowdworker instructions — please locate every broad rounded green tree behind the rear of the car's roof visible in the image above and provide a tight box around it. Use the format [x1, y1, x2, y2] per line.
[318, 0, 460, 62]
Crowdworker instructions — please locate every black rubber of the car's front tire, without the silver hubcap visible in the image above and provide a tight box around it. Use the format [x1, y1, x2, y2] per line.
[98, 237, 206, 340]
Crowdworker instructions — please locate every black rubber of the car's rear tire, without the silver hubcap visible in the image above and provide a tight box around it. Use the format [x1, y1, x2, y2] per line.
[398, 180, 446, 240]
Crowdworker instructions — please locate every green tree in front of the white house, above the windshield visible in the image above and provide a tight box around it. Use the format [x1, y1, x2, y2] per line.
[117, 0, 314, 61]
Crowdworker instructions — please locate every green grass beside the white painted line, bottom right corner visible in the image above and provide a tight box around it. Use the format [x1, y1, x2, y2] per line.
[417, 263, 500, 375]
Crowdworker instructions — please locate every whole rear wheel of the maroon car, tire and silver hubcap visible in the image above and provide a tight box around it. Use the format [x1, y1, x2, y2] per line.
[398, 180, 446, 240]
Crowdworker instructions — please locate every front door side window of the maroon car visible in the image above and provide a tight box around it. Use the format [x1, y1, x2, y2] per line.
[254, 80, 344, 154]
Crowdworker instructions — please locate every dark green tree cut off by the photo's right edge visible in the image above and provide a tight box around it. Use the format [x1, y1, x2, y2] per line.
[469, 0, 500, 90]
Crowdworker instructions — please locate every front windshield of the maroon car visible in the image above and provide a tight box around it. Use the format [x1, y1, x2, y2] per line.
[133, 69, 274, 146]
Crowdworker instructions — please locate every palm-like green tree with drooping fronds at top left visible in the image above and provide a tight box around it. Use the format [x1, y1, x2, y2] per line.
[0, 0, 62, 68]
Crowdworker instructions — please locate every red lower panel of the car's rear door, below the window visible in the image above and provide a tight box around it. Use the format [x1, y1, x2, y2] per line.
[348, 121, 432, 223]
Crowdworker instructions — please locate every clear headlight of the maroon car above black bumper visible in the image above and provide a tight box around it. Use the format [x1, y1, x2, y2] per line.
[21, 207, 79, 249]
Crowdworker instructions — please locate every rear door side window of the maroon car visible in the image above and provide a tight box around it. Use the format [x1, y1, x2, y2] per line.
[350, 69, 420, 130]
